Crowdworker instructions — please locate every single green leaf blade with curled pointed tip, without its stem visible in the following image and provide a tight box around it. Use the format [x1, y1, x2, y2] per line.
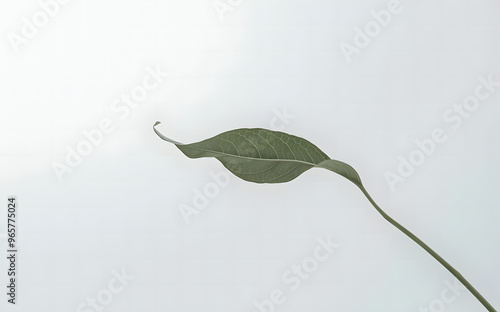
[153, 122, 362, 186]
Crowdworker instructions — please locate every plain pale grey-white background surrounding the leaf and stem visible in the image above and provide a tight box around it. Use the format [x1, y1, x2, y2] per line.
[0, 0, 500, 312]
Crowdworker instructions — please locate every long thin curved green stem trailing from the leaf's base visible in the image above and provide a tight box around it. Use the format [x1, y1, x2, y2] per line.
[358, 184, 496, 312]
